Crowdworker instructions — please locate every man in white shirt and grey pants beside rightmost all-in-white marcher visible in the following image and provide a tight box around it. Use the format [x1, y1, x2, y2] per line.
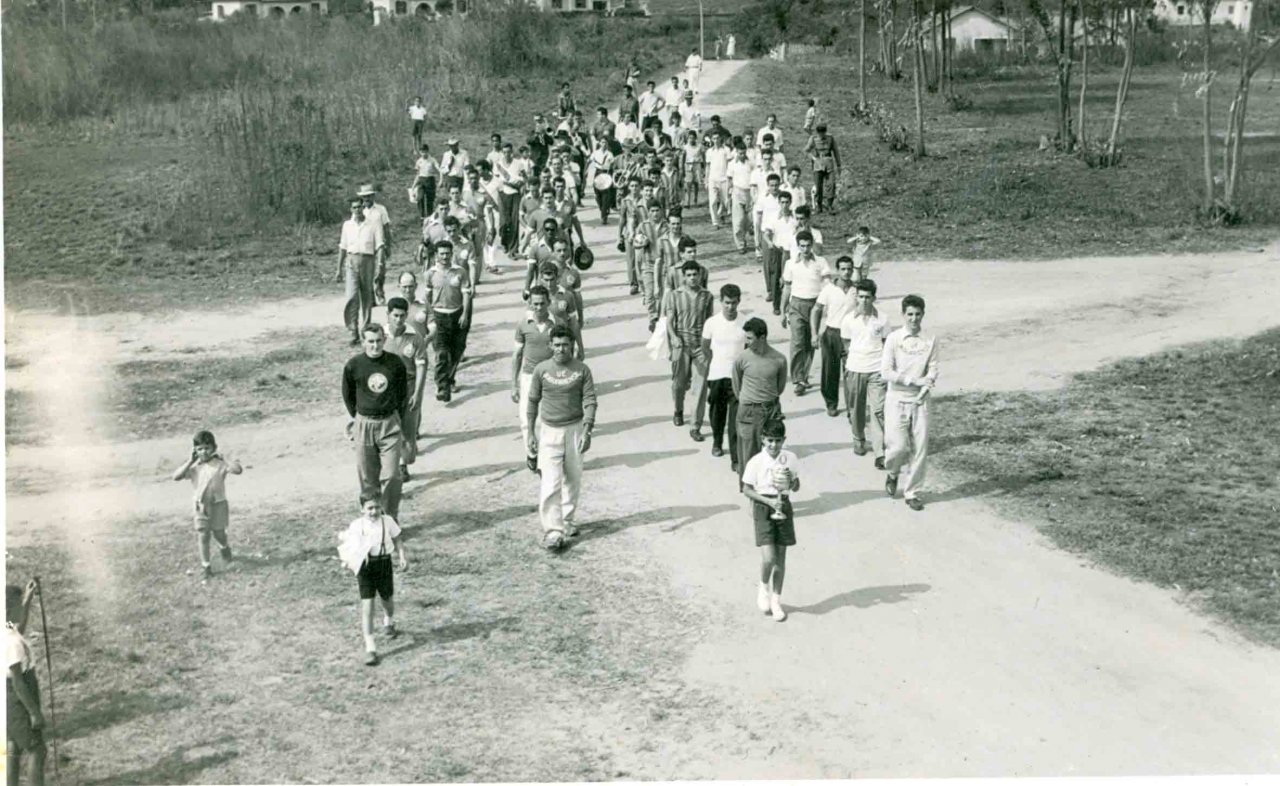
[840, 279, 890, 470]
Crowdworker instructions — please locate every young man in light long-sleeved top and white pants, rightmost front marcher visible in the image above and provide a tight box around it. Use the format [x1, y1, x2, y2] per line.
[881, 294, 938, 511]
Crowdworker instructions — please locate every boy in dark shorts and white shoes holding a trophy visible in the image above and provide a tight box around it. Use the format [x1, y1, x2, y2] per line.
[742, 420, 800, 622]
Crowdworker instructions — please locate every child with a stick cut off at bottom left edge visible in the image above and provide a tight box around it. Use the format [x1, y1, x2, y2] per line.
[4, 581, 45, 786]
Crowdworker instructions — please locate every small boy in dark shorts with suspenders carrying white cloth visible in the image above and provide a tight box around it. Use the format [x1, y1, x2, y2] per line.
[338, 495, 408, 666]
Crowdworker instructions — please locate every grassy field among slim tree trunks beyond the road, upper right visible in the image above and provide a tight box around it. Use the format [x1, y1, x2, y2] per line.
[751, 58, 1280, 259]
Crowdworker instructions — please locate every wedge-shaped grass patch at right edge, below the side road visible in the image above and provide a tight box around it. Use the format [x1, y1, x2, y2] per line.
[933, 330, 1280, 644]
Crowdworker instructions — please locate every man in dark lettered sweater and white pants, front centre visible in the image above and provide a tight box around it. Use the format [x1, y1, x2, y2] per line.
[526, 326, 595, 552]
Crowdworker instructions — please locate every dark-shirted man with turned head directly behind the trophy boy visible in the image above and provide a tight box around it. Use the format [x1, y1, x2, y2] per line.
[732, 316, 787, 490]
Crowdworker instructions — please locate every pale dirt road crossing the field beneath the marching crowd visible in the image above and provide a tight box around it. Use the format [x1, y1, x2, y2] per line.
[6, 63, 1280, 778]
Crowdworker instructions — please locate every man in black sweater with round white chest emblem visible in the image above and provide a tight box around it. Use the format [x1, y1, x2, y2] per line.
[342, 323, 408, 518]
